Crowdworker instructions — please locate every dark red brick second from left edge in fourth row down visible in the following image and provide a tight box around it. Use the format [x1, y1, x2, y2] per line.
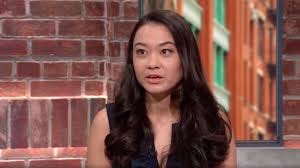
[17, 62, 40, 78]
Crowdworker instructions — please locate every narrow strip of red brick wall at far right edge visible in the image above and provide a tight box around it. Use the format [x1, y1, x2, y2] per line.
[281, 0, 300, 148]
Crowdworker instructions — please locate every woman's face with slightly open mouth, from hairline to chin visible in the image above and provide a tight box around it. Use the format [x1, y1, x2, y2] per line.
[133, 23, 182, 96]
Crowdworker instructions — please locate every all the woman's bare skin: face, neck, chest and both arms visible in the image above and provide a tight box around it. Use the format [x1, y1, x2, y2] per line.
[87, 23, 236, 168]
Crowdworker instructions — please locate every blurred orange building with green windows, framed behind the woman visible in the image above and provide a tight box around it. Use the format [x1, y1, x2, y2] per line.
[143, 0, 276, 140]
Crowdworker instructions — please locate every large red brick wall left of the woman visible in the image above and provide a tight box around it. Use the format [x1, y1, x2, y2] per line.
[0, 0, 138, 168]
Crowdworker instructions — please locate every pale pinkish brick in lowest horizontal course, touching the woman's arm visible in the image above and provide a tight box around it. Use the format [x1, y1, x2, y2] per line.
[57, 147, 87, 158]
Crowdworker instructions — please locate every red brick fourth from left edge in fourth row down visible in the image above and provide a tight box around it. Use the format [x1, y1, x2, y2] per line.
[72, 62, 95, 77]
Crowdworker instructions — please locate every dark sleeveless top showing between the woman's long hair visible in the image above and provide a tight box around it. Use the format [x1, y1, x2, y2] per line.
[106, 104, 180, 168]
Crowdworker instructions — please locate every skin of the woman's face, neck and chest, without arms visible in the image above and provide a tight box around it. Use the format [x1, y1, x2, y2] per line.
[133, 23, 182, 165]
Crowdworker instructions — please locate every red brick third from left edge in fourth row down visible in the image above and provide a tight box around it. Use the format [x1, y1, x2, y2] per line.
[44, 62, 68, 78]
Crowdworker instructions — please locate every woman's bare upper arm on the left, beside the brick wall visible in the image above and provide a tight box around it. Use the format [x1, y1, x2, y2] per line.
[86, 109, 111, 168]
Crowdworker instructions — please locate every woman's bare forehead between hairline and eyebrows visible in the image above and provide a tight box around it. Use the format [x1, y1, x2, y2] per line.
[134, 23, 174, 44]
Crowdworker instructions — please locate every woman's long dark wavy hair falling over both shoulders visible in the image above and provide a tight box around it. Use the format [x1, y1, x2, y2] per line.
[105, 10, 232, 168]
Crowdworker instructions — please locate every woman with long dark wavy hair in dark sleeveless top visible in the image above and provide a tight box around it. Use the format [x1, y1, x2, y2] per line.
[87, 11, 236, 168]
